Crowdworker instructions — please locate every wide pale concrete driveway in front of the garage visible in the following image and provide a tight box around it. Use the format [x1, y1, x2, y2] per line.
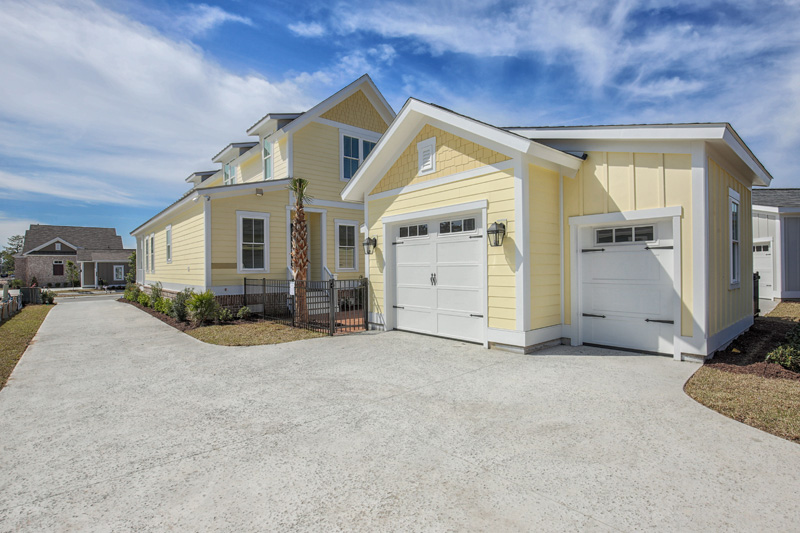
[0, 300, 800, 531]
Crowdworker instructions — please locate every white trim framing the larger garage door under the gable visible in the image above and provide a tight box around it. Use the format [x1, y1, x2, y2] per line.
[382, 200, 489, 347]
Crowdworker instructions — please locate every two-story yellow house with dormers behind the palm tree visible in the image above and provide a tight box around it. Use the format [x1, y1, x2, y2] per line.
[131, 75, 394, 295]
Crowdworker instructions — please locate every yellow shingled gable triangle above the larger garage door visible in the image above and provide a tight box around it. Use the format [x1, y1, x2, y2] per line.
[372, 124, 509, 194]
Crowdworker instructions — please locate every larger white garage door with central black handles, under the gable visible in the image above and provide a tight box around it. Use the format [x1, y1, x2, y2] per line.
[392, 215, 486, 342]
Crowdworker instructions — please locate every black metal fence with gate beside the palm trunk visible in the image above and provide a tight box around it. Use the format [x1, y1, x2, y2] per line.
[244, 278, 369, 335]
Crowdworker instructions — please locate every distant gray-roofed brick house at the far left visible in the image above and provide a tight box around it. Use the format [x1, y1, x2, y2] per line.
[14, 224, 133, 287]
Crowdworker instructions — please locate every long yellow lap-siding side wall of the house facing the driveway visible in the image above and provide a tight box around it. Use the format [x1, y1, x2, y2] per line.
[145, 202, 205, 286]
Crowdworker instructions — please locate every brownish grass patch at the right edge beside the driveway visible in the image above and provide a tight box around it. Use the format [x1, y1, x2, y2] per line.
[686, 366, 800, 443]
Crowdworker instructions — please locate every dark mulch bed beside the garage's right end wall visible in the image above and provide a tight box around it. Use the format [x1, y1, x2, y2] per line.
[706, 317, 800, 381]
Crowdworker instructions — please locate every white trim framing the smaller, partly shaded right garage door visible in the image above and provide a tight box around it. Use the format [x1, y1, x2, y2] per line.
[569, 206, 683, 360]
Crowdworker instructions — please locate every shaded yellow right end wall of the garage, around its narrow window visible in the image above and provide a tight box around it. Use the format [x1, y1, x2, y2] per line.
[708, 159, 753, 335]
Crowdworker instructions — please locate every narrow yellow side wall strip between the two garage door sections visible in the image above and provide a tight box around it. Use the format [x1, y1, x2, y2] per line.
[528, 165, 561, 329]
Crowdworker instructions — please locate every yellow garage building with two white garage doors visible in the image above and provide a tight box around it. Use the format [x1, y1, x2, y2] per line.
[342, 99, 772, 359]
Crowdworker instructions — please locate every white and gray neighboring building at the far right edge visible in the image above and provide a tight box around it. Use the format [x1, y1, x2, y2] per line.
[753, 189, 800, 299]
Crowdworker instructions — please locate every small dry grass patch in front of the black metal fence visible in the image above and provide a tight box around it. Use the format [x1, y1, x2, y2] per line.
[186, 322, 325, 346]
